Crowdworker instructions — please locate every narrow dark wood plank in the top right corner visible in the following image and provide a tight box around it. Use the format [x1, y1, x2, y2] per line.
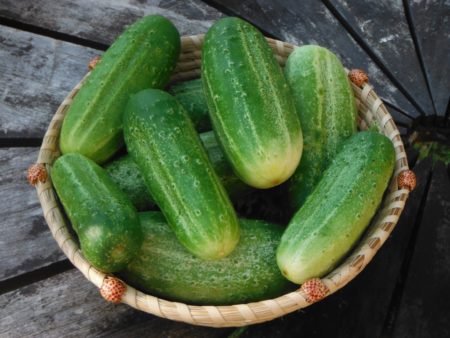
[406, 0, 450, 116]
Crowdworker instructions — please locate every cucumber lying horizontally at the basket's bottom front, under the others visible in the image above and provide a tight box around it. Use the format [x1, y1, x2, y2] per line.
[120, 212, 293, 305]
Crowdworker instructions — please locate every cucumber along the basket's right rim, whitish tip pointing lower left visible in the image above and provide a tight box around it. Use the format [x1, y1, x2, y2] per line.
[277, 132, 395, 284]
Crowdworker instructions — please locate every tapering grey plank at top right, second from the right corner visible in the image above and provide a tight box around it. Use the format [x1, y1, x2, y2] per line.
[327, 0, 435, 115]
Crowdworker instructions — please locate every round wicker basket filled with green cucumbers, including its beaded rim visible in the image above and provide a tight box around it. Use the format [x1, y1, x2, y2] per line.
[28, 16, 415, 327]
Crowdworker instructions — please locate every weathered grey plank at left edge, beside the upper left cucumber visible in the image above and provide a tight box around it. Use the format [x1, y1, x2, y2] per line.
[0, 26, 99, 139]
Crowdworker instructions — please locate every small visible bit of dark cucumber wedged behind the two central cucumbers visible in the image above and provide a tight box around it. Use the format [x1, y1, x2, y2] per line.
[168, 79, 212, 132]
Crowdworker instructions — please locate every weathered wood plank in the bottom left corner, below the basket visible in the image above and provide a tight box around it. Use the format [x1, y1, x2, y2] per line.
[0, 270, 231, 338]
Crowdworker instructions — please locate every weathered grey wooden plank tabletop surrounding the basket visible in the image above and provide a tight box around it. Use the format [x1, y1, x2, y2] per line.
[0, 0, 450, 337]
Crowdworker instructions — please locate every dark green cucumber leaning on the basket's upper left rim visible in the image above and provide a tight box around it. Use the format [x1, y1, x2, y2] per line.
[60, 15, 180, 163]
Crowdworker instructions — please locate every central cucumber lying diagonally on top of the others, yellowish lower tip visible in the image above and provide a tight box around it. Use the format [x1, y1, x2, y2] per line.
[124, 89, 239, 259]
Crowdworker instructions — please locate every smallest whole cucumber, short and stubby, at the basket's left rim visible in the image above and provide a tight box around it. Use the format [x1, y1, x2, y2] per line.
[51, 153, 142, 272]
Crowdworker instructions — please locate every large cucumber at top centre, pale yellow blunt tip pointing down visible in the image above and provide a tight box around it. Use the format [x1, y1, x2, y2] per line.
[202, 18, 303, 188]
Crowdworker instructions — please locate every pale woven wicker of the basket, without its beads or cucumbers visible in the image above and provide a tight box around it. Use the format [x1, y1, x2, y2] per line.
[36, 35, 409, 327]
